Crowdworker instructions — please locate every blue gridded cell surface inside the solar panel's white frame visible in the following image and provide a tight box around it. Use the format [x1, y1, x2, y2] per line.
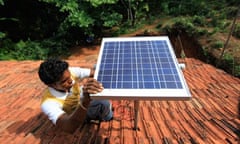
[97, 40, 182, 89]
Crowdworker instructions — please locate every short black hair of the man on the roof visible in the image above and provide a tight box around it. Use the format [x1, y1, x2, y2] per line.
[38, 58, 69, 85]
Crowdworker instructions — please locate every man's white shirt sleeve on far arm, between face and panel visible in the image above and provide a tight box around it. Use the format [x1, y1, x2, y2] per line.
[69, 67, 91, 78]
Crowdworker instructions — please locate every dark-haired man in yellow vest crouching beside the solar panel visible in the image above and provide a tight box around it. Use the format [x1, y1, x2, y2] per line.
[38, 59, 112, 133]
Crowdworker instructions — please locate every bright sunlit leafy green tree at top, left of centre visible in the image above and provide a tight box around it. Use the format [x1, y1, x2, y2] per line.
[40, 0, 121, 35]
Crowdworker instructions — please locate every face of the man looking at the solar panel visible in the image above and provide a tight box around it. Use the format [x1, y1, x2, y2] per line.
[52, 69, 73, 92]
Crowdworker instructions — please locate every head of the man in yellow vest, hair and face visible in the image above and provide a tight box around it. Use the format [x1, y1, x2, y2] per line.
[38, 58, 72, 91]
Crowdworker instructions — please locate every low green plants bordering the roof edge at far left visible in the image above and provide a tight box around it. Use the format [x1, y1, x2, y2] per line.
[0, 39, 69, 60]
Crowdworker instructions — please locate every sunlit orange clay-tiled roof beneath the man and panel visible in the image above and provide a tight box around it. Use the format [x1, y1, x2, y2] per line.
[0, 58, 240, 144]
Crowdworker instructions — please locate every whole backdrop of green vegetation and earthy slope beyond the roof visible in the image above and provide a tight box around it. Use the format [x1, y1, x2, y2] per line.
[0, 0, 240, 77]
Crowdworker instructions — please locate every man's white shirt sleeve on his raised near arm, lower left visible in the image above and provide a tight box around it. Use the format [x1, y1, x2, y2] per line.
[41, 100, 65, 125]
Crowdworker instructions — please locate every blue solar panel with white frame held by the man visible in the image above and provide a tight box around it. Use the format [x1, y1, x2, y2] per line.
[90, 36, 190, 99]
